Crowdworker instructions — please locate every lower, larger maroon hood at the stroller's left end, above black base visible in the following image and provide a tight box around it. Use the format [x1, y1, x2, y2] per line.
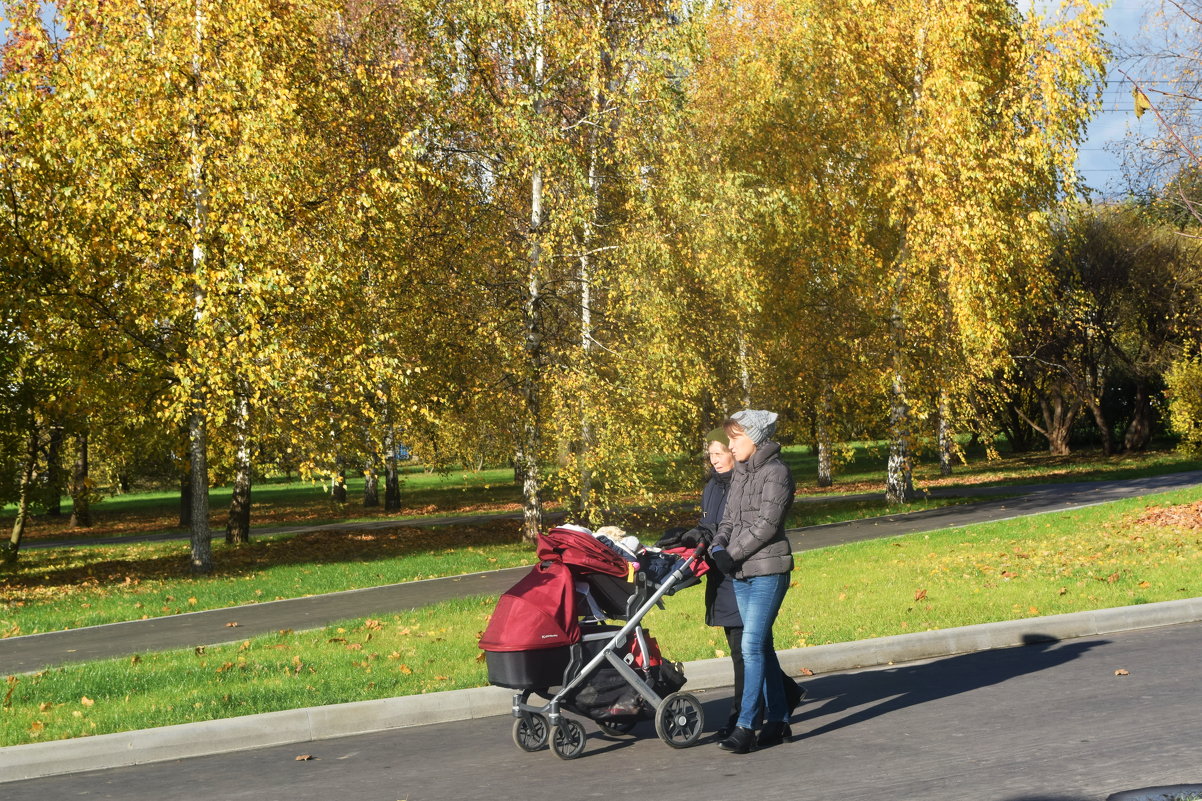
[480, 562, 581, 652]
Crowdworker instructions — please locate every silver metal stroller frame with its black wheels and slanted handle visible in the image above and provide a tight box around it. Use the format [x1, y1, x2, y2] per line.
[504, 545, 706, 759]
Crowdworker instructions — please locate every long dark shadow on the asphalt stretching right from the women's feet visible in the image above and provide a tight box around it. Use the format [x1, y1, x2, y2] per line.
[793, 635, 1109, 740]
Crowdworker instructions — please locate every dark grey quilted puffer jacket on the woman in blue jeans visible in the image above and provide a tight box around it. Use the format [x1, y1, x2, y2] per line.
[714, 441, 796, 579]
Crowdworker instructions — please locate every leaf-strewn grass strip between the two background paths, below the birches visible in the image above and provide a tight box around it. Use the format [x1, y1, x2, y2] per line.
[0, 498, 972, 639]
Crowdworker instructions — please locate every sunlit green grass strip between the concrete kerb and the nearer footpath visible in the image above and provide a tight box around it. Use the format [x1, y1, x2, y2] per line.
[0, 488, 1202, 744]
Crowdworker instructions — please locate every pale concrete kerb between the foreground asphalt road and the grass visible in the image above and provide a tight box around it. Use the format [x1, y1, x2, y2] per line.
[0, 598, 1202, 782]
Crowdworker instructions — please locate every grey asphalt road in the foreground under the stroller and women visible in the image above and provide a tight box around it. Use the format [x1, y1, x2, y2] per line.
[2, 624, 1202, 801]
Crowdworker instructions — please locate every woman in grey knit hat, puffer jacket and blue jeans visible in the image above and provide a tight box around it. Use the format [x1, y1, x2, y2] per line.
[710, 409, 795, 754]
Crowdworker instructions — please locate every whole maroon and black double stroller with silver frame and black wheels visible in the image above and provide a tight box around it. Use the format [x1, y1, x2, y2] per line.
[480, 527, 706, 759]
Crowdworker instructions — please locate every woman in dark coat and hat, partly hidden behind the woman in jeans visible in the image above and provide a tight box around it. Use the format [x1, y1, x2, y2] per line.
[656, 428, 805, 740]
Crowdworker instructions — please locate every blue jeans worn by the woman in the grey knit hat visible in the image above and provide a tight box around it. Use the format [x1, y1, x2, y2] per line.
[732, 572, 789, 729]
